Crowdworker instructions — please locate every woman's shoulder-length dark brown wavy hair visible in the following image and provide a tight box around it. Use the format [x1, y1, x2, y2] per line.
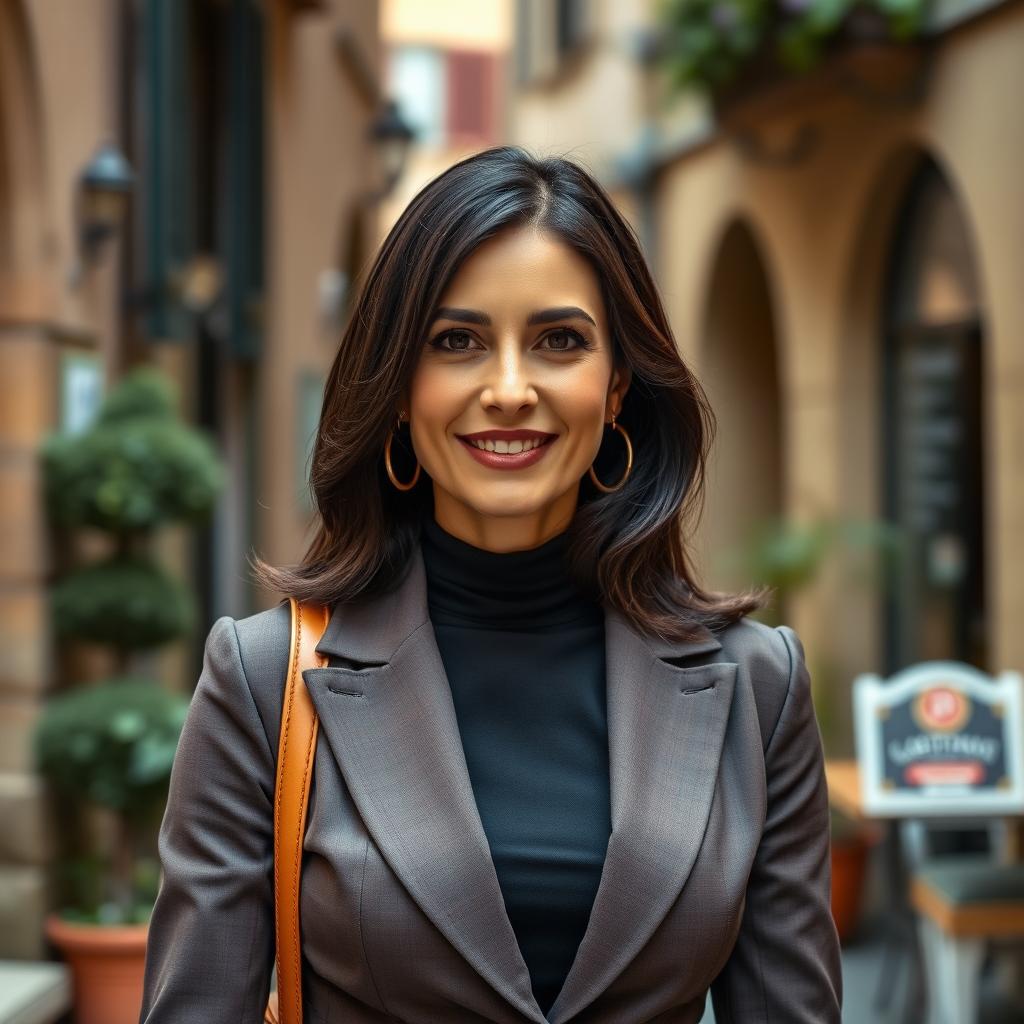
[251, 146, 766, 640]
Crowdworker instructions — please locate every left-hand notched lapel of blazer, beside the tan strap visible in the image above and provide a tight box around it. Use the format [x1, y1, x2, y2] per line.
[303, 550, 545, 1024]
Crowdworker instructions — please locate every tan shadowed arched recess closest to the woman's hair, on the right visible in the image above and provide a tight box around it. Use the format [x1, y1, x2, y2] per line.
[700, 220, 784, 614]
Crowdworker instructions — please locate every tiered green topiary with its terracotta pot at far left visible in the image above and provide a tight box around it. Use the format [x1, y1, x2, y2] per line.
[34, 368, 223, 1024]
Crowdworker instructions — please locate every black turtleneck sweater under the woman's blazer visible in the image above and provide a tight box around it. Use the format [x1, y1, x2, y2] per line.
[422, 519, 611, 1013]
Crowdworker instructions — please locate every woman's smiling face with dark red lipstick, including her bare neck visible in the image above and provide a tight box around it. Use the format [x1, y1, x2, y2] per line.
[401, 227, 629, 551]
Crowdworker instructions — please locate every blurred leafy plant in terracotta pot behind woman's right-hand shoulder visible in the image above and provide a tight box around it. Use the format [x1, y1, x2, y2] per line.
[725, 518, 903, 941]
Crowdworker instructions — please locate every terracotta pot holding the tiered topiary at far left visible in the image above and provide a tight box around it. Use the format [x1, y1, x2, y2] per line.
[46, 914, 150, 1024]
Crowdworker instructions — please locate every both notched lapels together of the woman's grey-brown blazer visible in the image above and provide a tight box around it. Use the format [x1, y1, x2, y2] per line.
[303, 548, 736, 1024]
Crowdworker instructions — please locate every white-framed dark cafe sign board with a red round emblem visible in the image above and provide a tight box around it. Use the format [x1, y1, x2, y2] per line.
[853, 662, 1024, 817]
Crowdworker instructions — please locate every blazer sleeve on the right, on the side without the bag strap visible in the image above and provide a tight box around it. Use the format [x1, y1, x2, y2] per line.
[711, 626, 843, 1024]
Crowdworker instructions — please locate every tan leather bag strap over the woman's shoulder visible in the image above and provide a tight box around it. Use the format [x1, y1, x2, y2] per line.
[266, 597, 331, 1024]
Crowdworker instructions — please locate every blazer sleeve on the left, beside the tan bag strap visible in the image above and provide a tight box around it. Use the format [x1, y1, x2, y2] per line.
[139, 615, 275, 1024]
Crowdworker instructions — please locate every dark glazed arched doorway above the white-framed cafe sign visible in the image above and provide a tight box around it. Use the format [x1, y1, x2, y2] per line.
[881, 159, 989, 673]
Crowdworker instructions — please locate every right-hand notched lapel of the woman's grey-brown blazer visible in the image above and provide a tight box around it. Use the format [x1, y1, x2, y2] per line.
[548, 607, 736, 1024]
